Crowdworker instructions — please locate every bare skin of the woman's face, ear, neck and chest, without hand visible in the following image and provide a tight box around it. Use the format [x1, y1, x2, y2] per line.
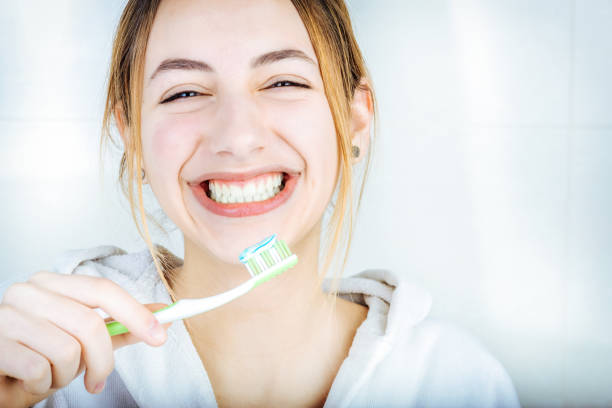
[118, 0, 372, 406]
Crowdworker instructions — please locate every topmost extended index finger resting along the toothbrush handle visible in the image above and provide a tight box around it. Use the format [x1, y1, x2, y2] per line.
[29, 271, 166, 346]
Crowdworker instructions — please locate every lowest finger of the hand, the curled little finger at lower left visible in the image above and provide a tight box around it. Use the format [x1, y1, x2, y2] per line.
[0, 337, 51, 394]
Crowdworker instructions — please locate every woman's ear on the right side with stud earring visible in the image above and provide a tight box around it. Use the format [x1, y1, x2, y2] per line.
[351, 78, 374, 164]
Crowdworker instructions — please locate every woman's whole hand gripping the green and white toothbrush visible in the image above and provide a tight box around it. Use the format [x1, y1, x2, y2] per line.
[0, 271, 172, 407]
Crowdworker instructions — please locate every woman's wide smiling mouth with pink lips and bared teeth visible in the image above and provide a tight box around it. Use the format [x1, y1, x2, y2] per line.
[190, 172, 300, 217]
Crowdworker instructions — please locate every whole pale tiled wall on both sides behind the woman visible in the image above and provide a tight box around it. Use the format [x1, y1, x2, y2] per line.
[0, 0, 612, 407]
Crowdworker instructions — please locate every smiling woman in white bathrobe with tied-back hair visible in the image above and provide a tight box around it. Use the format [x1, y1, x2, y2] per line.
[0, 0, 518, 407]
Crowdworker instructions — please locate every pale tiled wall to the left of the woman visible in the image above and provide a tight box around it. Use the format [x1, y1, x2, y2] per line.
[0, 0, 182, 286]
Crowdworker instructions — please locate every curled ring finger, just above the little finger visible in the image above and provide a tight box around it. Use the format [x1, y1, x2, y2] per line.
[0, 305, 81, 388]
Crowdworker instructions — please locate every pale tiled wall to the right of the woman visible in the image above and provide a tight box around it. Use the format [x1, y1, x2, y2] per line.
[342, 0, 612, 407]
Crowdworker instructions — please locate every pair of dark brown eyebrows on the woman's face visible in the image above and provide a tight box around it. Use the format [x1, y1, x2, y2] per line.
[149, 49, 317, 82]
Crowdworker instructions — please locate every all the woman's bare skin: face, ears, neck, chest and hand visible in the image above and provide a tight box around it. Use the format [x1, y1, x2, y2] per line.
[0, 0, 372, 407]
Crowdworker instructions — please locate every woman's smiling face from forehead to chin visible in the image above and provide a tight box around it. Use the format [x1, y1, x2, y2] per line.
[142, 0, 337, 263]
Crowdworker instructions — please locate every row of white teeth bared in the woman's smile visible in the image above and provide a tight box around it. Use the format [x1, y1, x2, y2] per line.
[208, 174, 283, 204]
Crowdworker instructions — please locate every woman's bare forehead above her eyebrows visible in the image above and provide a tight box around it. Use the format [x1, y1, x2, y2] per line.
[145, 0, 316, 73]
